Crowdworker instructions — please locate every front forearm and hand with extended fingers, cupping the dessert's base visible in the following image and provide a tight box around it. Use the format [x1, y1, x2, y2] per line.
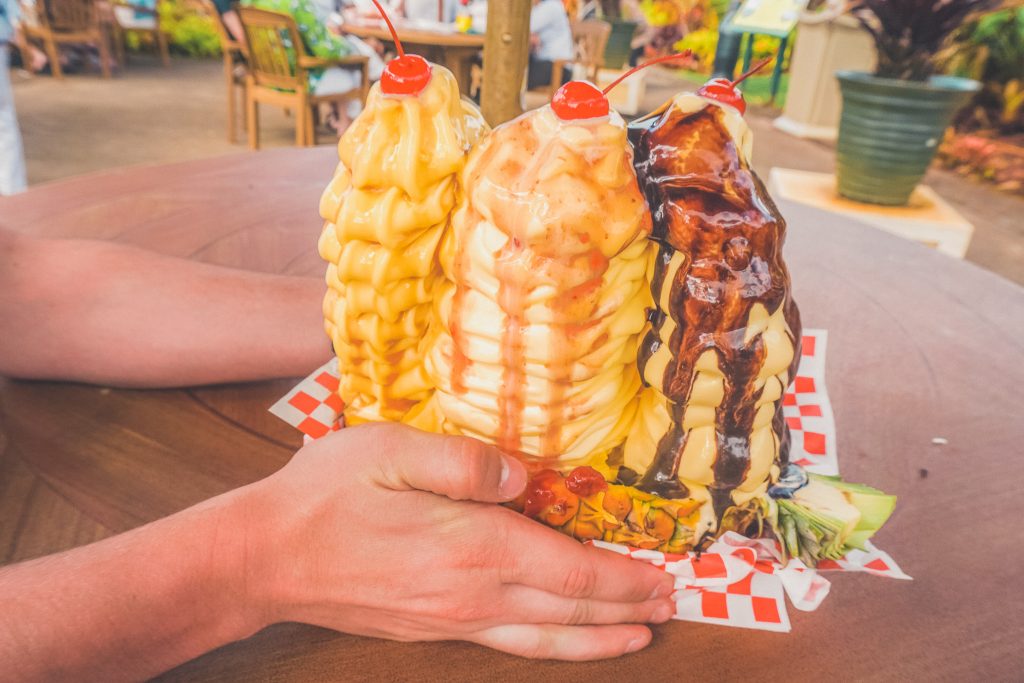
[0, 424, 674, 681]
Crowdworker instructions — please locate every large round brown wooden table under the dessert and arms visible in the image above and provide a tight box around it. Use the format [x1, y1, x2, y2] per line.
[0, 148, 1024, 682]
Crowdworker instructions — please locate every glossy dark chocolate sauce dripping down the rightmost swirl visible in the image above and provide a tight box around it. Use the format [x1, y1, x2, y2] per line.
[630, 106, 801, 518]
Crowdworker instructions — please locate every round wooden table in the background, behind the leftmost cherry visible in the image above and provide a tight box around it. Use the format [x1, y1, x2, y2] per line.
[341, 18, 483, 95]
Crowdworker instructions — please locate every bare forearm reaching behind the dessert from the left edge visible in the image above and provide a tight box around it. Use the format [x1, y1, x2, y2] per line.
[0, 228, 330, 386]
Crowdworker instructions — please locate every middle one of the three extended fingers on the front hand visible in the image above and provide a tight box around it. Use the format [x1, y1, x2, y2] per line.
[502, 585, 676, 626]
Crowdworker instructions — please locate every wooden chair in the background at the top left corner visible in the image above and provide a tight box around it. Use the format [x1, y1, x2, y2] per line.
[23, 0, 111, 79]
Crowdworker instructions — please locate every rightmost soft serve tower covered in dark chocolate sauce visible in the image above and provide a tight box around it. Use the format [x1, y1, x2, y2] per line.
[621, 87, 801, 516]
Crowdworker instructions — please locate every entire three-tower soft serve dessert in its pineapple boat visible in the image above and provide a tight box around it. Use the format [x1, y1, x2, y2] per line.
[321, 49, 894, 564]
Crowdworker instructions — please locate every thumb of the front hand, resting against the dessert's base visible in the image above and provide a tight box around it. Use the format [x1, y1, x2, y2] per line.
[355, 425, 526, 503]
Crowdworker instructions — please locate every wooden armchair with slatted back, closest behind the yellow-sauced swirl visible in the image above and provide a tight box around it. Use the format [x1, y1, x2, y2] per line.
[239, 7, 370, 150]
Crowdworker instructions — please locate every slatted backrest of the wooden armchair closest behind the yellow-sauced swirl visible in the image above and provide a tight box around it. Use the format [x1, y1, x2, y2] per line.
[239, 7, 307, 90]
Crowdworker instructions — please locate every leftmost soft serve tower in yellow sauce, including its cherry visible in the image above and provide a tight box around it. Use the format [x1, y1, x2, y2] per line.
[319, 13, 486, 424]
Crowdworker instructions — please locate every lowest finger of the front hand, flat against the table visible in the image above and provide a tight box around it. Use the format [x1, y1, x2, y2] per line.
[470, 624, 651, 661]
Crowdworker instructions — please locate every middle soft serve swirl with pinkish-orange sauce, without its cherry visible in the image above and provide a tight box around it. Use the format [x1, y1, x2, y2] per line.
[427, 106, 652, 466]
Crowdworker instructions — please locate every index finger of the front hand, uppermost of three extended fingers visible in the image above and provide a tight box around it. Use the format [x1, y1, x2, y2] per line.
[500, 515, 675, 602]
